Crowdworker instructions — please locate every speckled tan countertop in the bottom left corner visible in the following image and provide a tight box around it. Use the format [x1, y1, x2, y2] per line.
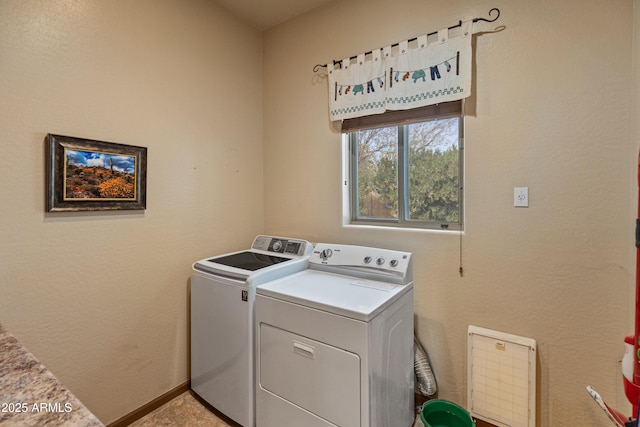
[0, 325, 104, 427]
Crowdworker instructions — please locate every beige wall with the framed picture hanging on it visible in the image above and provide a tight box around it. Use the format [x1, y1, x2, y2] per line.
[0, 0, 263, 423]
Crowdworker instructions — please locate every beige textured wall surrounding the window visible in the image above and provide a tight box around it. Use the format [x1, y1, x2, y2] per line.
[263, 0, 638, 426]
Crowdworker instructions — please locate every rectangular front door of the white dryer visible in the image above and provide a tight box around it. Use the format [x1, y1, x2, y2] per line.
[259, 323, 360, 427]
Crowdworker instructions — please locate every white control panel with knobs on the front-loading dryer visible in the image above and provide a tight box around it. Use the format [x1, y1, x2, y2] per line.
[309, 243, 411, 275]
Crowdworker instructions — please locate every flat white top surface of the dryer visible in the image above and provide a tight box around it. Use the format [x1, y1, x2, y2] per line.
[256, 270, 413, 322]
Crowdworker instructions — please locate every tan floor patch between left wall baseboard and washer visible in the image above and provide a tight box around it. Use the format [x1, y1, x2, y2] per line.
[130, 391, 232, 427]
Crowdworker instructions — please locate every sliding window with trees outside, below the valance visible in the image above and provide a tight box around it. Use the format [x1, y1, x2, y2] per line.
[342, 101, 464, 230]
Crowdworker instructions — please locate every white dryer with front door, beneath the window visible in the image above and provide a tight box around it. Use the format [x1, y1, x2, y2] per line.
[255, 243, 414, 427]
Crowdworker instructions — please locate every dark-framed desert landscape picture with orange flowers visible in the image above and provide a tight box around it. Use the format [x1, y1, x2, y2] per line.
[46, 134, 147, 212]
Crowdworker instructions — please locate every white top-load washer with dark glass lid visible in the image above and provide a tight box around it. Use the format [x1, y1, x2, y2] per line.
[191, 236, 313, 427]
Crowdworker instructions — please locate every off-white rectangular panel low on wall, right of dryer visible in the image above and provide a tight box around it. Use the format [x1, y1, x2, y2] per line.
[467, 325, 536, 427]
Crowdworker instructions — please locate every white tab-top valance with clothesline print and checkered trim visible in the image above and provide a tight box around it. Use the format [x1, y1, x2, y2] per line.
[327, 21, 473, 121]
